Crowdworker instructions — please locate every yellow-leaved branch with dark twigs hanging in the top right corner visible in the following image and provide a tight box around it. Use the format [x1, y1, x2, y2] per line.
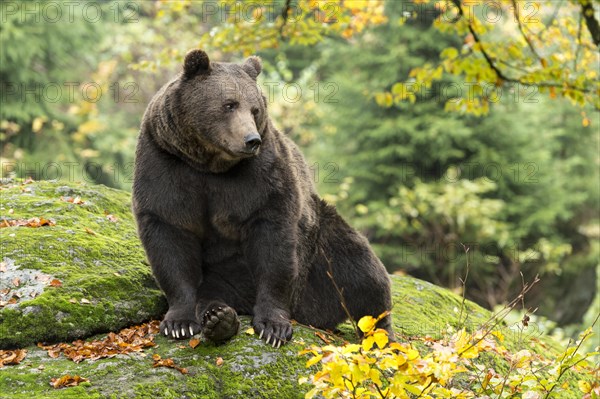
[380, 0, 600, 114]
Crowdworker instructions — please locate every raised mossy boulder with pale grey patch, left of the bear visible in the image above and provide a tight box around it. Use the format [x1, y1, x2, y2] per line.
[0, 182, 166, 348]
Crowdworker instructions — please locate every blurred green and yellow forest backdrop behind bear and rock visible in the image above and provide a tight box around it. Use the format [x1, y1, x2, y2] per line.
[0, 0, 600, 340]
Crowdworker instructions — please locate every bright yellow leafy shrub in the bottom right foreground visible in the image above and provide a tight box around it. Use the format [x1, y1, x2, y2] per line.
[299, 315, 600, 399]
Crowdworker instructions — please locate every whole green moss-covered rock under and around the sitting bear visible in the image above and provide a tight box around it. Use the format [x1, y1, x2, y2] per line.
[0, 182, 580, 399]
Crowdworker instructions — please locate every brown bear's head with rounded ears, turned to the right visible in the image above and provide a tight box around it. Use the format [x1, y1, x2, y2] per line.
[155, 50, 268, 171]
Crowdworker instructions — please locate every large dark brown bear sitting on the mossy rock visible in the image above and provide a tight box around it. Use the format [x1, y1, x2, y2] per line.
[133, 50, 393, 347]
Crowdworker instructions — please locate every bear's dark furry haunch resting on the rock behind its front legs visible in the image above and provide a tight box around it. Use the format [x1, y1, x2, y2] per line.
[293, 203, 394, 341]
